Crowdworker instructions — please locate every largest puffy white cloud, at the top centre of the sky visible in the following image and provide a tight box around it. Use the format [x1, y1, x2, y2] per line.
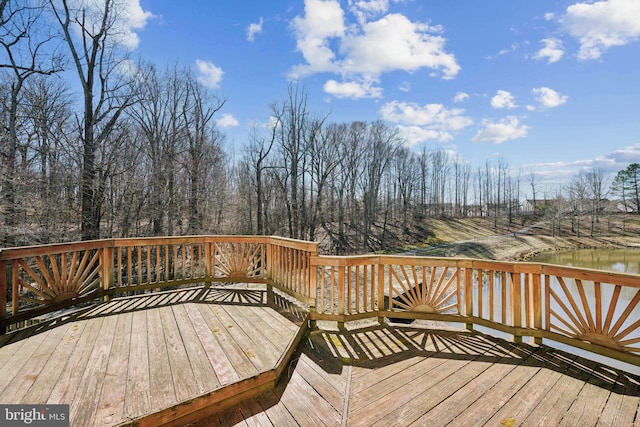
[290, 0, 460, 98]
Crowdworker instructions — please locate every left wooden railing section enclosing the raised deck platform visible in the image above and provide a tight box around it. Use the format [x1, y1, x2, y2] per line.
[0, 236, 317, 331]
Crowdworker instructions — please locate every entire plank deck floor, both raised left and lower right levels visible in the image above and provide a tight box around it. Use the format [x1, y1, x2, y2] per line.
[0, 289, 640, 427]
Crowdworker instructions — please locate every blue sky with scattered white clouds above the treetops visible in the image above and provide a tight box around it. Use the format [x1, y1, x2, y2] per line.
[121, 0, 640, 187]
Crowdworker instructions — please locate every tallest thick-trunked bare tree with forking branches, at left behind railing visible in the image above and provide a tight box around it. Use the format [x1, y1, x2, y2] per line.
[49, 0, 137, 240]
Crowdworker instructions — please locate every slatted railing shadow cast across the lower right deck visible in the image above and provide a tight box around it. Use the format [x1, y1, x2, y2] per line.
[306, 324, 640, 396]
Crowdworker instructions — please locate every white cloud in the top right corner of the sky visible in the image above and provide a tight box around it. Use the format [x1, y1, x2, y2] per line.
[559, 0, 640, 60]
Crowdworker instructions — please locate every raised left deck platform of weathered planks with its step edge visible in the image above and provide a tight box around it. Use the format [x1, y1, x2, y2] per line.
[0, 285, 305, 427]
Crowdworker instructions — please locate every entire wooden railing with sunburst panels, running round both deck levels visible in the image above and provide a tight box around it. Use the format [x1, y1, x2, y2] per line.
[0, 236, 640, 365]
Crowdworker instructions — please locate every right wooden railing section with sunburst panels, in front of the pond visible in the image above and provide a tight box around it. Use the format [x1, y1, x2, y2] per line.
[311, 255, 640, 365]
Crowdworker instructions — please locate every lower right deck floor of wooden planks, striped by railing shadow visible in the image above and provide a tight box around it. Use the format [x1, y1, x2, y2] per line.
[192, 325, 640, 427]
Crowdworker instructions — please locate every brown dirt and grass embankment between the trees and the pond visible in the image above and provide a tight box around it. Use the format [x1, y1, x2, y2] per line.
[402, 215, 640, 261]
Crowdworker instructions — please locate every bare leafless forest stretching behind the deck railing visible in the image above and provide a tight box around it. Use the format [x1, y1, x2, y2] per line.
[0, 0, 640, 254]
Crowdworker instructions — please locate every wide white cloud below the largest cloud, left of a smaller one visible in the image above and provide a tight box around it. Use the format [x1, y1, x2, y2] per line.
[380, 101, 473, 145]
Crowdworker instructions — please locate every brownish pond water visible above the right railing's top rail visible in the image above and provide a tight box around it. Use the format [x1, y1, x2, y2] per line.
[527, 249, 640, 274]
